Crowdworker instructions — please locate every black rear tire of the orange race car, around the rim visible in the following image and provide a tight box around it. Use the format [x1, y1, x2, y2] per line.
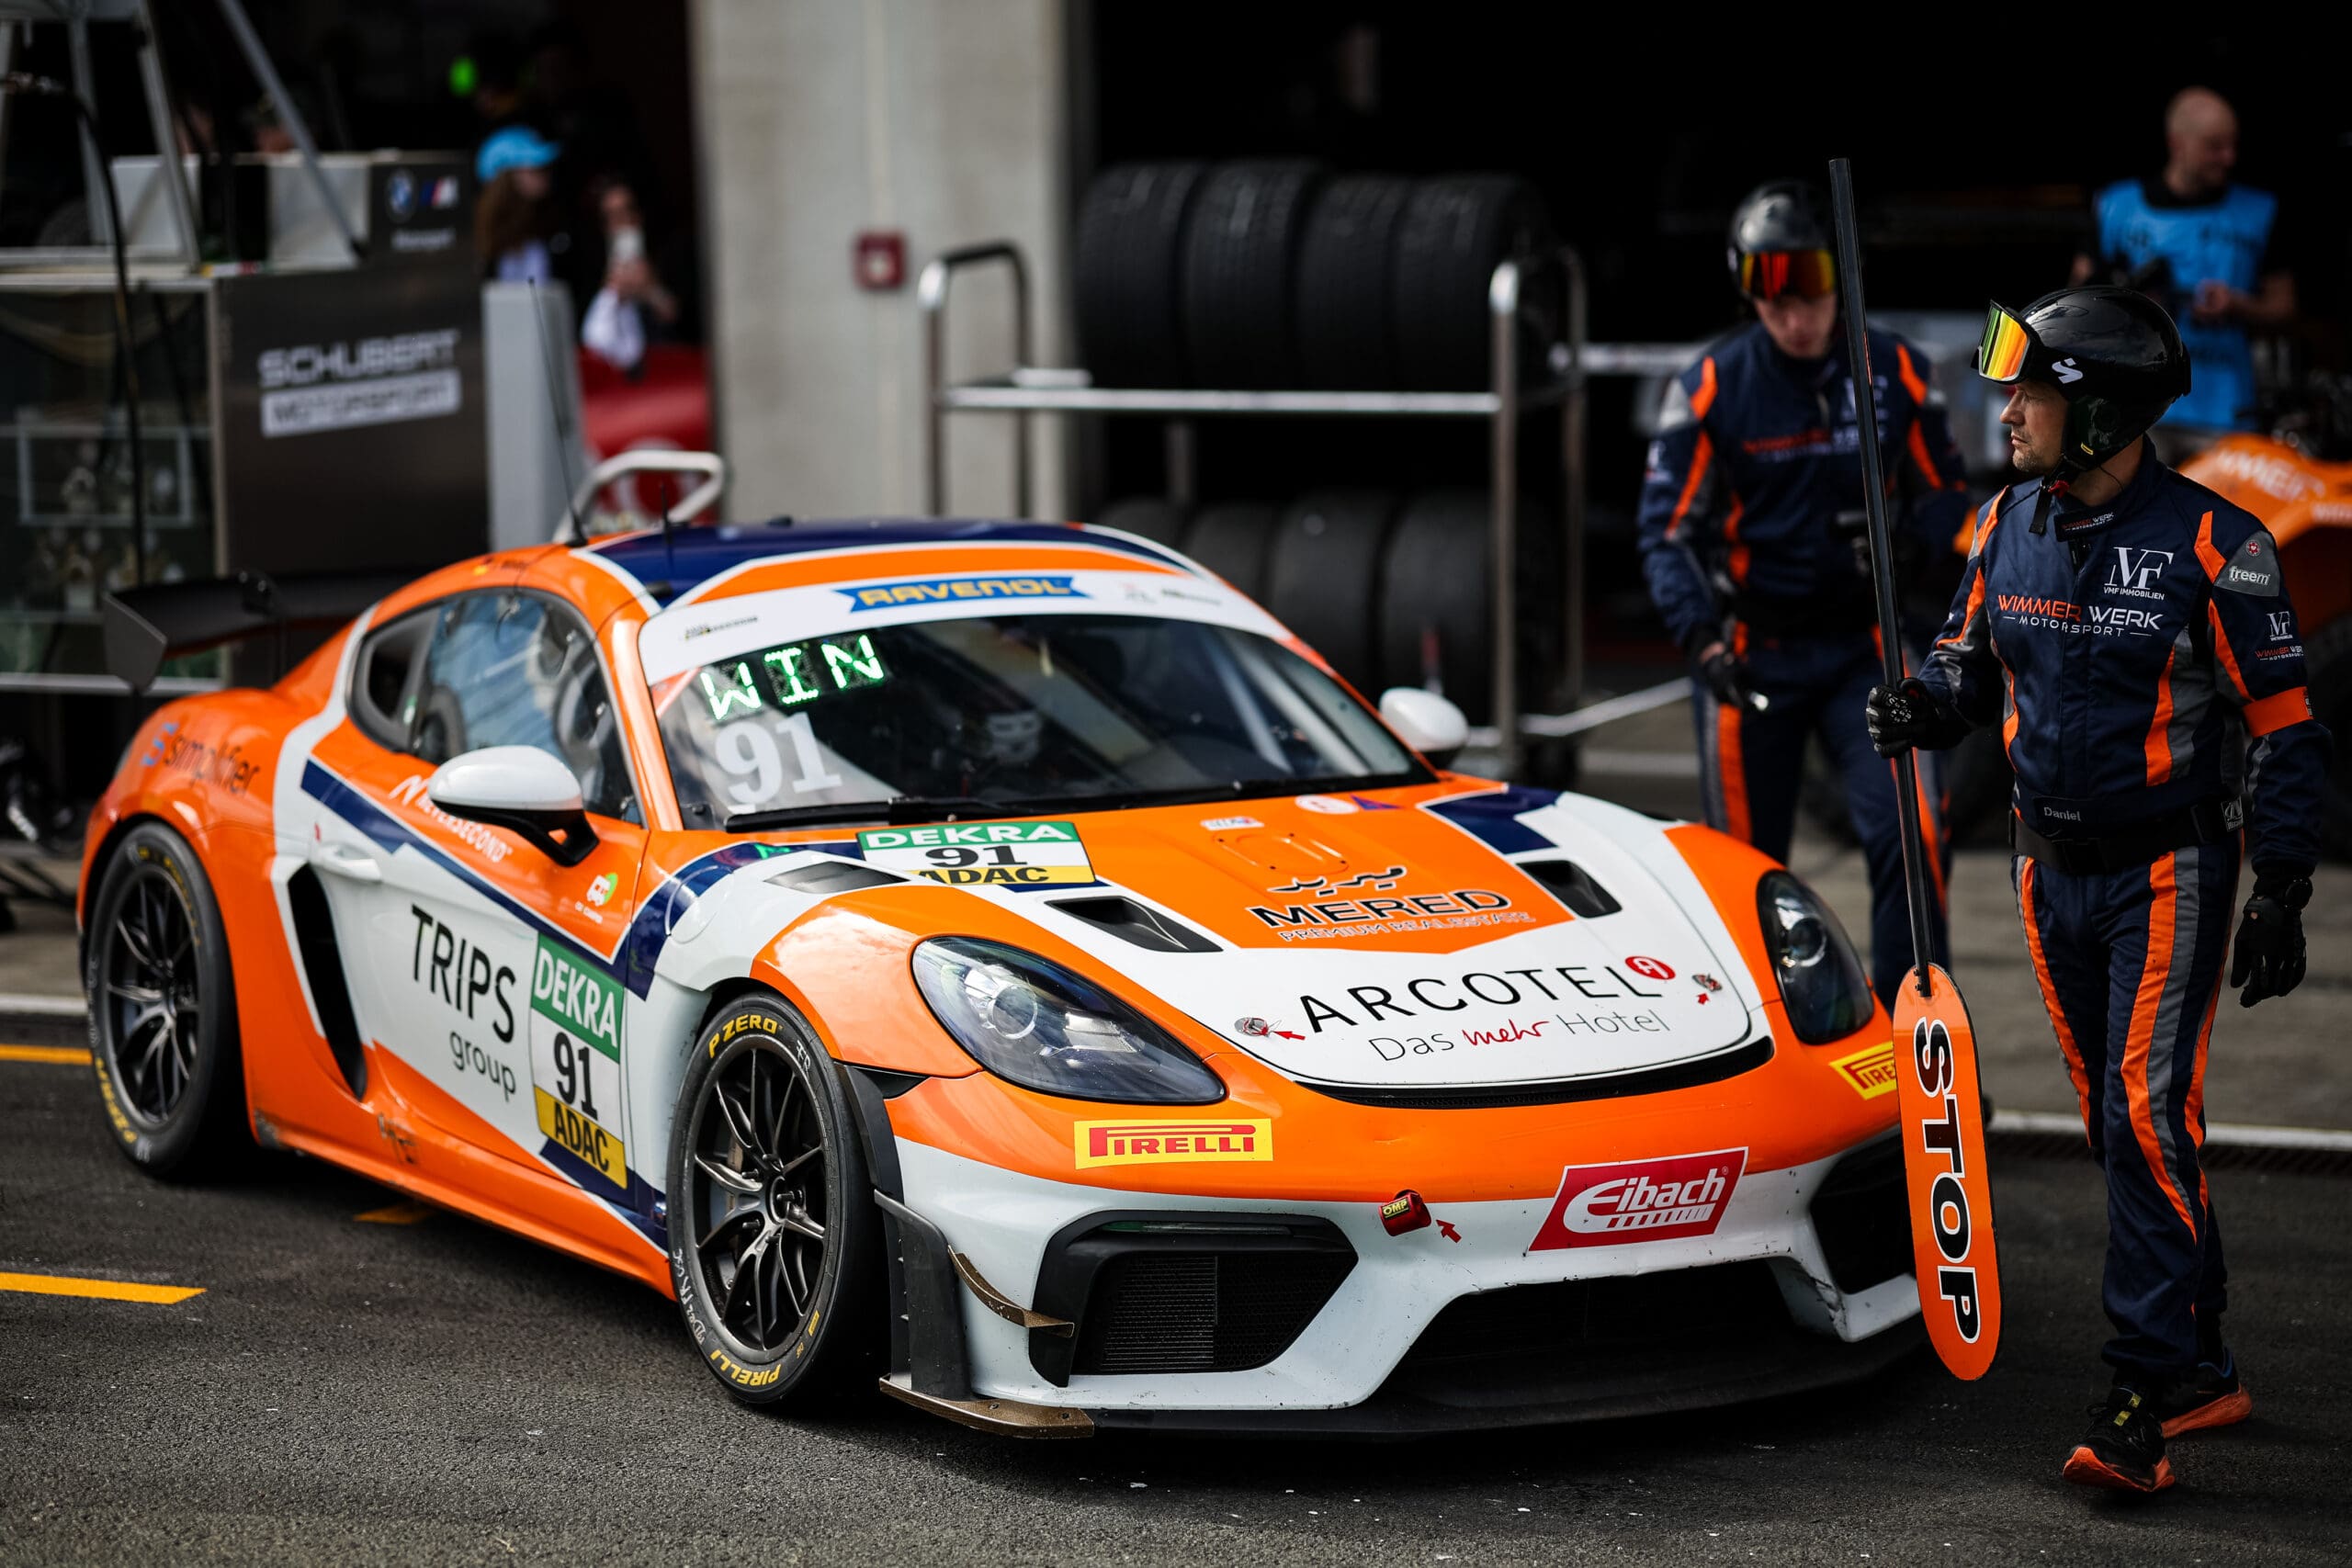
[83, 823, 252, 1178]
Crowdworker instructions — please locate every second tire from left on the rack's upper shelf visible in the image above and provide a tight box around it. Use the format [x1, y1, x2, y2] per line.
[1183, 160, 1322, 388]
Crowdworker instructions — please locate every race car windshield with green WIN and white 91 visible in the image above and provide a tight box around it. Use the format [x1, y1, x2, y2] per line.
[654, 614, 1428, 828]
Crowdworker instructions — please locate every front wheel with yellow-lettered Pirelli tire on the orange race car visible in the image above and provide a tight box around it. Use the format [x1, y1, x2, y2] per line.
[668, 995, 885, 1411]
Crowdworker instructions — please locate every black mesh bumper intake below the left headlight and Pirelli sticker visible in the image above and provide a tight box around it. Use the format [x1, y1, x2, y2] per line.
[1072, 1248, 1355, 1373]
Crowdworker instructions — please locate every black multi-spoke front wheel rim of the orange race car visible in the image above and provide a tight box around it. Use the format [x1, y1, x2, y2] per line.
[684, 1037, 831, 1359]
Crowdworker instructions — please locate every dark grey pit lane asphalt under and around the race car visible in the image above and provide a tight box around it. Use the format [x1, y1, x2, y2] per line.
[0, 1025, 2352, 1568]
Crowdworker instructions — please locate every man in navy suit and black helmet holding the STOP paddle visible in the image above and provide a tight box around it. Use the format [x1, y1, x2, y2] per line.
[1868, 287, 2331, 1493]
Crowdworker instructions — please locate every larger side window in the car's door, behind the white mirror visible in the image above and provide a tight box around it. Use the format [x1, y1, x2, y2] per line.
[407, 592, 642, 823]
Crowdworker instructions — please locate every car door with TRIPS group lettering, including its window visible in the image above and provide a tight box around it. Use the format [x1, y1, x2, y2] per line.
[318, 588, 644, 1201]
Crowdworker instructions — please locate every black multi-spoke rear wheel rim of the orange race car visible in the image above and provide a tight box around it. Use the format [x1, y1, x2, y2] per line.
[101, 867, 202, 1128]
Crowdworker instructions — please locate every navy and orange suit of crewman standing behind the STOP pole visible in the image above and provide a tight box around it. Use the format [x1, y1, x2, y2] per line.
[1639, 324, 1969, 1004]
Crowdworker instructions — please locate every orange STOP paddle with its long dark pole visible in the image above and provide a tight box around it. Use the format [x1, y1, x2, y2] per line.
[1830, 157, 2002, 1378]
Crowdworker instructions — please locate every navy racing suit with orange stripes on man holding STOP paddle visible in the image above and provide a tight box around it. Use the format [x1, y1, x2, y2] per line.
[1919, 454, 2331, 1380]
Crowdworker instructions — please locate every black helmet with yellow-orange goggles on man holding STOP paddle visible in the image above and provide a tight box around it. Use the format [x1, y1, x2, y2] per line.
[1975, 285, 2189, 478]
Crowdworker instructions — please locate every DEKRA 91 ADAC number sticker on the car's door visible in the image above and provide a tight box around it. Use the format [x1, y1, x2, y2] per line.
[529, 936, 628, 1187]
